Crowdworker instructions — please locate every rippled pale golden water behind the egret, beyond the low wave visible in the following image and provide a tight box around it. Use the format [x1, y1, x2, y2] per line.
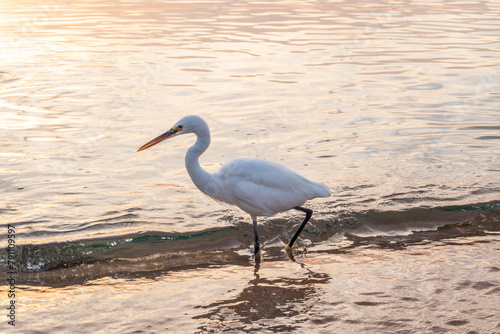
[0, 1, 500, 241]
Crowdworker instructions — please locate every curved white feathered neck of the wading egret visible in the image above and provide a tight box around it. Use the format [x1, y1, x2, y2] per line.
[185, 126, 218, 197]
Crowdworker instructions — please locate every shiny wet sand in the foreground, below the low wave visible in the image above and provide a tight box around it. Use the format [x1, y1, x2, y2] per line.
[5, 234, 500, 333]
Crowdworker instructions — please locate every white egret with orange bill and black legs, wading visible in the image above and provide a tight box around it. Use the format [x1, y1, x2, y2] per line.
[138, 115, 330, 254]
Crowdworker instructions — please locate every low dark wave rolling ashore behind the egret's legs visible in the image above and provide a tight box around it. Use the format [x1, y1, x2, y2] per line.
[0, 202, 500, 280]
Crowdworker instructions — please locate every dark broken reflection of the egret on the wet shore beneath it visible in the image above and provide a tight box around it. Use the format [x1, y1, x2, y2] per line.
[194, 253, 331, 333]
